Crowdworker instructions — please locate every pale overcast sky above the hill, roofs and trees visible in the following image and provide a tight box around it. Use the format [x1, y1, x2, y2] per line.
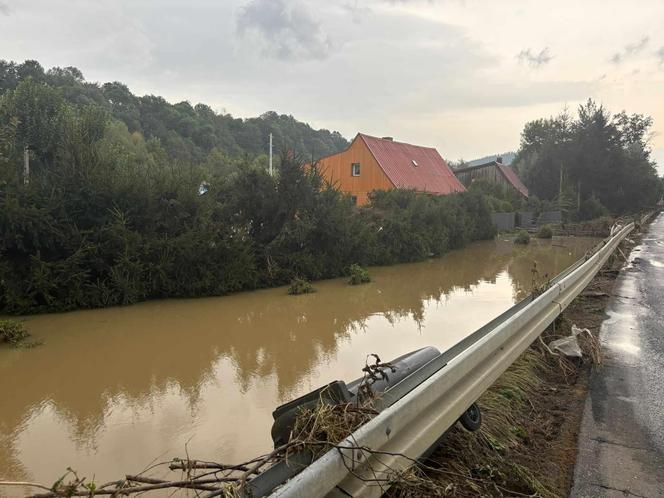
[0, 0, 664, 172]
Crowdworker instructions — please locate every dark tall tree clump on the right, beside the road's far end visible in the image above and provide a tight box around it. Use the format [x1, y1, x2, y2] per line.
[514, 100, 662, 218]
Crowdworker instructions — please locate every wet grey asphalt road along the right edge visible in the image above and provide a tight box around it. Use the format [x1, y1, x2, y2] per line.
[570, 214, 664, 498]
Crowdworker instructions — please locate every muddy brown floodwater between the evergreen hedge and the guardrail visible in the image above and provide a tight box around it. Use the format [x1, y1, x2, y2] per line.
[0, 238, 596, 495]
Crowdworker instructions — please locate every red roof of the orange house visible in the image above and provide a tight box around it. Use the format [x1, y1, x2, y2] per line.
[355, 133, 466, 194]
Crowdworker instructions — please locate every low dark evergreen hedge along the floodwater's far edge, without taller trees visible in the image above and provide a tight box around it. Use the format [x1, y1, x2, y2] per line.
[0, 144, 495, 314]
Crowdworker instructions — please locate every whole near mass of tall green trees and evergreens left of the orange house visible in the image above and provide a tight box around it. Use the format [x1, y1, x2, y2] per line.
[0, 65, 494, 314]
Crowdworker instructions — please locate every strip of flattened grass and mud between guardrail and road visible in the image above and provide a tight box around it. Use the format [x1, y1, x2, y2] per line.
[390, 223, 641, 498]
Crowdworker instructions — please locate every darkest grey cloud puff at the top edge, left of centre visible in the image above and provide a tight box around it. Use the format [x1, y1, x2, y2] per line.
[237, 0, 333, 60]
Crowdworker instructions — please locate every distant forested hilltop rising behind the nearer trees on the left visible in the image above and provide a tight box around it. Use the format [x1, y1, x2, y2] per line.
[0, 60, 348, 163]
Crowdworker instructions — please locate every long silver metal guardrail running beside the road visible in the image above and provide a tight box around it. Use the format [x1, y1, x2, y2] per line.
[271, 223, 634, 498]
